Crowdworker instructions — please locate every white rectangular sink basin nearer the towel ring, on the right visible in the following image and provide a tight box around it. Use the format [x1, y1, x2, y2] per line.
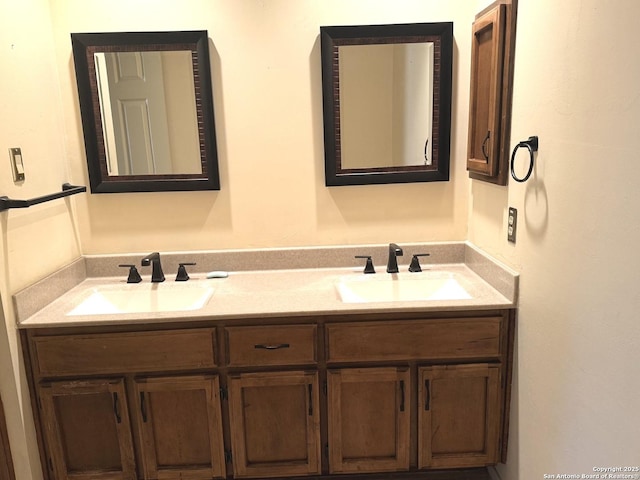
[336, 272, 471, 303]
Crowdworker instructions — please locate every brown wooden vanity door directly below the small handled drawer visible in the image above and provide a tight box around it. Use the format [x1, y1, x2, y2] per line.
[229, 371, 320, 477]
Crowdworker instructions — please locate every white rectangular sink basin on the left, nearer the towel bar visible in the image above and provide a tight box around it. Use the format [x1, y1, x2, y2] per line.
[67, 282, 214, 315]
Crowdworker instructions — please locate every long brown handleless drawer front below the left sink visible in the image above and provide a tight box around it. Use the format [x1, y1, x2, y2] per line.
[33, 328, 216, 377]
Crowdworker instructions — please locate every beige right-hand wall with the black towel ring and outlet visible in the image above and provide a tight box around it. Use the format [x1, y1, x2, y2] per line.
[469, 0, 640, 480]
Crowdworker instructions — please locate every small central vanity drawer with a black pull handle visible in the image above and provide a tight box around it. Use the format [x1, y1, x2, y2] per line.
[225, 325, 317, 367]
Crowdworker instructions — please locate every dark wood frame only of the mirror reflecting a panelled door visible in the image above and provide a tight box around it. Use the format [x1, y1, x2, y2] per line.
[71, 30, 220, 193]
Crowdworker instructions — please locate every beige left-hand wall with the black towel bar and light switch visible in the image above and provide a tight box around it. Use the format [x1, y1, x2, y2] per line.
[0, 0, 80, 480]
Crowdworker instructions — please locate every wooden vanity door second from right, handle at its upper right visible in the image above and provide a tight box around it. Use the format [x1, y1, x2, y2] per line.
[327, 367, 411, 473]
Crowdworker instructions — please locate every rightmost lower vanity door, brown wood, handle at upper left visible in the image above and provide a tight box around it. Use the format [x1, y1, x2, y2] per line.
[418, 364, 500, 468]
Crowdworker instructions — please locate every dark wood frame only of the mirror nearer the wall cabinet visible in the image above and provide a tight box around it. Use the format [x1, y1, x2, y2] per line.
[320, 22, 453, 186]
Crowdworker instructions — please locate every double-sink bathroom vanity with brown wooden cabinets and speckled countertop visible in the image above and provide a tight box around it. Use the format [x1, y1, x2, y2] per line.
[14, 246, 518, 480]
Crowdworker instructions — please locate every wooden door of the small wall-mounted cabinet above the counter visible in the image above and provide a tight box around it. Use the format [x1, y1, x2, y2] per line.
[467, 5, 506, 176]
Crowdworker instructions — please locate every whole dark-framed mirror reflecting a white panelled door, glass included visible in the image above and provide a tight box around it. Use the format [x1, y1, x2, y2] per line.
[71, 30, 220, 193]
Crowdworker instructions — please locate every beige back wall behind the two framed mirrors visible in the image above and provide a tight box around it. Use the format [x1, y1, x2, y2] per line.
[51, 0, 473, 254]
